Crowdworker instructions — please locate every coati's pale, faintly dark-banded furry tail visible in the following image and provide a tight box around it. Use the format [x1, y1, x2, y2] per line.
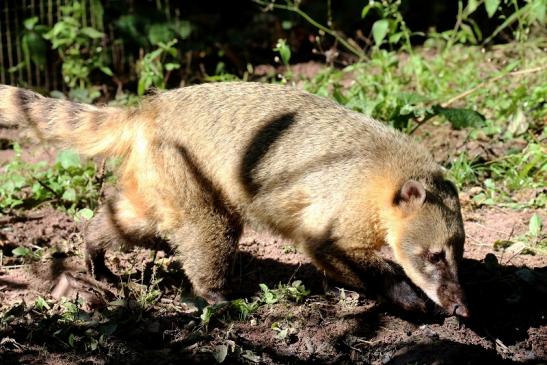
[0, 85, 138, 156]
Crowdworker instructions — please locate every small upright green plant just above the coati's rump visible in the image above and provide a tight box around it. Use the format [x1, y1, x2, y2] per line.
[137, 39, 180, 95]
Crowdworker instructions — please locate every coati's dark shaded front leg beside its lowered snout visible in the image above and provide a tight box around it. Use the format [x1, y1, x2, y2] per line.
[306, 239, 426, 312]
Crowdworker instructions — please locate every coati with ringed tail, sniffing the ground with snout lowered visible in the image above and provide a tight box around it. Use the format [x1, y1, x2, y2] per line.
[0, 82, 468, 317]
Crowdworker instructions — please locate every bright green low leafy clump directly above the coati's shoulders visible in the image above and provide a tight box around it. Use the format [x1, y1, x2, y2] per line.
[306, 50, 484, 132]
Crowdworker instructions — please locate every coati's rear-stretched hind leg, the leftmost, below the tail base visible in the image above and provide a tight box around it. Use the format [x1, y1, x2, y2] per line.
[85, 194, 156, 282]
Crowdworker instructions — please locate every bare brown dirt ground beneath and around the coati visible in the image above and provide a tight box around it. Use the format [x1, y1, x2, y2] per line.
[0, 116, 547, 364]
